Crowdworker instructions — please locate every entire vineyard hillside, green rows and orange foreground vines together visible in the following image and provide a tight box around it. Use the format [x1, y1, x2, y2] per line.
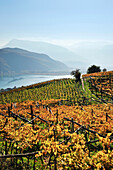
[0, 73, 113, 170]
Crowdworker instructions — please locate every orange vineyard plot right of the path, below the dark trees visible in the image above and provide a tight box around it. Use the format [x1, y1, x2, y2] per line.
[83, 71, 113, 102]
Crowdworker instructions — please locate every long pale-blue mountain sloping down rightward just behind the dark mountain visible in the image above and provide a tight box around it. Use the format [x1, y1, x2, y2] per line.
[5, 39, 85, 68]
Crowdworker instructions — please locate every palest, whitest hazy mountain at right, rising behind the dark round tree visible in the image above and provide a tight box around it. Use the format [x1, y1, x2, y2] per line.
[70, 41, 113, 70]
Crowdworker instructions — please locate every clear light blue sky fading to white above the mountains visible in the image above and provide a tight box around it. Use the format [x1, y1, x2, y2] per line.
[0, 0, 113, 45]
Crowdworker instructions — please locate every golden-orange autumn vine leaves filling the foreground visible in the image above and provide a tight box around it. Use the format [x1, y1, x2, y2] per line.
[0, 100, 113, 169]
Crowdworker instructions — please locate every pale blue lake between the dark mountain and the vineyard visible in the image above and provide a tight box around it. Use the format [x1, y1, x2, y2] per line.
[0, 75, 72, 89]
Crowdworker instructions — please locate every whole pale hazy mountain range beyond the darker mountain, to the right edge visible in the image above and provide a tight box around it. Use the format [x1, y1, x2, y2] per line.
[2, 39, 113, 72]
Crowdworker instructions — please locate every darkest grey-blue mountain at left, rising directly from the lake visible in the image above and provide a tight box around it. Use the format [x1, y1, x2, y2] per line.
[0, 48, 68, 74]
